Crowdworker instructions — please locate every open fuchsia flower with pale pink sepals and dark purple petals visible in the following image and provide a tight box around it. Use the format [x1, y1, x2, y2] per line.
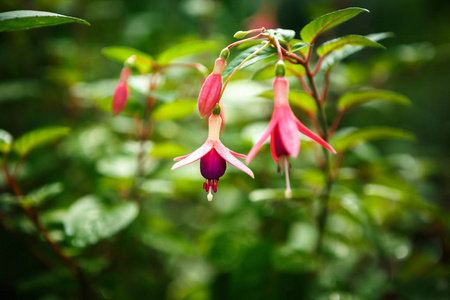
[172, 113, 254, 201]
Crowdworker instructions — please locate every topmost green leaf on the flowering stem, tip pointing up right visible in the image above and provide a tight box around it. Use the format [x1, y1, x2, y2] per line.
[300, 7, 369, 44]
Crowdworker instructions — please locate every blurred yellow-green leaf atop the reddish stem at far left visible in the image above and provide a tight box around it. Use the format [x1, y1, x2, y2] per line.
[14, 126, 70, 157]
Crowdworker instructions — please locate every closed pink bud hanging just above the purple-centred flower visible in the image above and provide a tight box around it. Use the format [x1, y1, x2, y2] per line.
[198, 57, 225, 118]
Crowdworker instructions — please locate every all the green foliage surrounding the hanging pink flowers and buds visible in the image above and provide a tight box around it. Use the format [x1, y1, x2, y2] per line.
[0, 0, 450, 300]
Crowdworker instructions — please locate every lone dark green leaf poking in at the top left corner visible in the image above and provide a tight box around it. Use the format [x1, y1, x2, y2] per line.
[0, 10, 90, 32]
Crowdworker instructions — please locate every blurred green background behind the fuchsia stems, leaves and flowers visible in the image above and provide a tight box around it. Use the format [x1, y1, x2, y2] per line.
[0, 0, 450, 300]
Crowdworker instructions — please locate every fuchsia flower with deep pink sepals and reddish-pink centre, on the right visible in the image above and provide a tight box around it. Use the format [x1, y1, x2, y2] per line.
[246, 76, 336, 198]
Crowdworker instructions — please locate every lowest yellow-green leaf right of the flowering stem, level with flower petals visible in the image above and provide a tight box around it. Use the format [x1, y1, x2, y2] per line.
[332, 127, 415, 153]
